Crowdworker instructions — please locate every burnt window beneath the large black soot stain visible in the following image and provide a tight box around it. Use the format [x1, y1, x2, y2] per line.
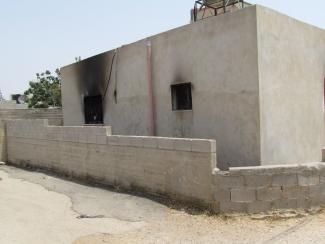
[84, 96, 103, 125]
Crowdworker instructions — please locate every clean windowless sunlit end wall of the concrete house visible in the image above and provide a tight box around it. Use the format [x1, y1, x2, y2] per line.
[257, 6, 325, 164]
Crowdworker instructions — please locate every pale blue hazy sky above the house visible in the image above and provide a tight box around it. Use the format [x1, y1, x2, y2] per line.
[0, 0, 325, 98]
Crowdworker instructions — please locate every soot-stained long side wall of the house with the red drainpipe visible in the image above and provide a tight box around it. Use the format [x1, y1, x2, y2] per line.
[61, 6, 260, 168]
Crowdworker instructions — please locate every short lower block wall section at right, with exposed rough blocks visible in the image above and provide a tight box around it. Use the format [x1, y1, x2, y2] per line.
[213, 163, 325, 213]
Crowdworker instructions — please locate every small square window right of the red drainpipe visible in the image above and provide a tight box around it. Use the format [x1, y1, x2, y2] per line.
[171, 83, 192, 111]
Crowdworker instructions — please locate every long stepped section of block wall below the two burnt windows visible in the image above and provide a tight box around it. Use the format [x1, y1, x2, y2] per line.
[7, 120, 216, 203]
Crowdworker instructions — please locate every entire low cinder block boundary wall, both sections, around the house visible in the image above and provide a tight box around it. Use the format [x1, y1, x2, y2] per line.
[4, 120, 325, 213]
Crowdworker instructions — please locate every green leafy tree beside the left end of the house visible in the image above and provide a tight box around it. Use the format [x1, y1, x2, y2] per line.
[24, 69, 62, 108]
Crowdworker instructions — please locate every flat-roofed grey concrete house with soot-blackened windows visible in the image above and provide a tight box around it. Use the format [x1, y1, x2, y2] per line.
[61, 5, 325, 169]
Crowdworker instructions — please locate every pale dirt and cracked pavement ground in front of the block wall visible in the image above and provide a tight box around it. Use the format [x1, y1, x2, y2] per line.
[0, 166, 325, 244]
